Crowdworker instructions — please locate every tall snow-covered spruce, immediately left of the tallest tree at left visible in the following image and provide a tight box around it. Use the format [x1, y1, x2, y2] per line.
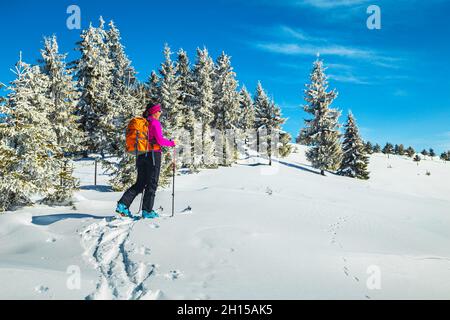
[40, 36, 81, 205]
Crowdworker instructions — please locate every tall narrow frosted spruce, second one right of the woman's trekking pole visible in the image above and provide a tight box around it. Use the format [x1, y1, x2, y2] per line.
[193, 48, 217, 168]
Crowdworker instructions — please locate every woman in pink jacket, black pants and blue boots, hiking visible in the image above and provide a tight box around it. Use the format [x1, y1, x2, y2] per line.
[116, 105, 175, 219]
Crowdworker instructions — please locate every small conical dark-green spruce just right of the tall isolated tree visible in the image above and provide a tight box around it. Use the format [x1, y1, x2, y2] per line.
[338, 112, 369, 180]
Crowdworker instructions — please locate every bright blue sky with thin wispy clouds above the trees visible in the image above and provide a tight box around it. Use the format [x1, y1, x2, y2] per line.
[0, 0, 450, 152]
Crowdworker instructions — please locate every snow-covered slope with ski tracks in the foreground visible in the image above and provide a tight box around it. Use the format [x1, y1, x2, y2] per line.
[0, 147, 450, 299]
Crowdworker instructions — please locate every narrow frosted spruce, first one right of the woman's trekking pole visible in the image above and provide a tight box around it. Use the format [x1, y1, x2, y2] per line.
[177, 49, 197, 171]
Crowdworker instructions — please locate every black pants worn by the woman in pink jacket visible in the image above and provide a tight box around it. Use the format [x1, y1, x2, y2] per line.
[119, 152, 161, 212]
